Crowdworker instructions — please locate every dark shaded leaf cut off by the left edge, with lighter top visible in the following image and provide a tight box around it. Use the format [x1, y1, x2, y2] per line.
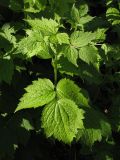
[0, 57, 14, 84]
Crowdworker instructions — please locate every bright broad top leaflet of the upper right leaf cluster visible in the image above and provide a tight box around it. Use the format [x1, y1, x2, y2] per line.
[70, 31, 95, 48]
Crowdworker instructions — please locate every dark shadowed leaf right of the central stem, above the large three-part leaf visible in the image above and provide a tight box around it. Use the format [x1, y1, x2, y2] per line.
[58, 56, 103, 85]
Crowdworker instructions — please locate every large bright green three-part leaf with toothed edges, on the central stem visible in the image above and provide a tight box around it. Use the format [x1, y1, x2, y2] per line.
[16, 79, 88, 143]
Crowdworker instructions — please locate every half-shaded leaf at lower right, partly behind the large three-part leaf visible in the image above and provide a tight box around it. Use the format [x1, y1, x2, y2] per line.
[77, 108, 111, 147]
